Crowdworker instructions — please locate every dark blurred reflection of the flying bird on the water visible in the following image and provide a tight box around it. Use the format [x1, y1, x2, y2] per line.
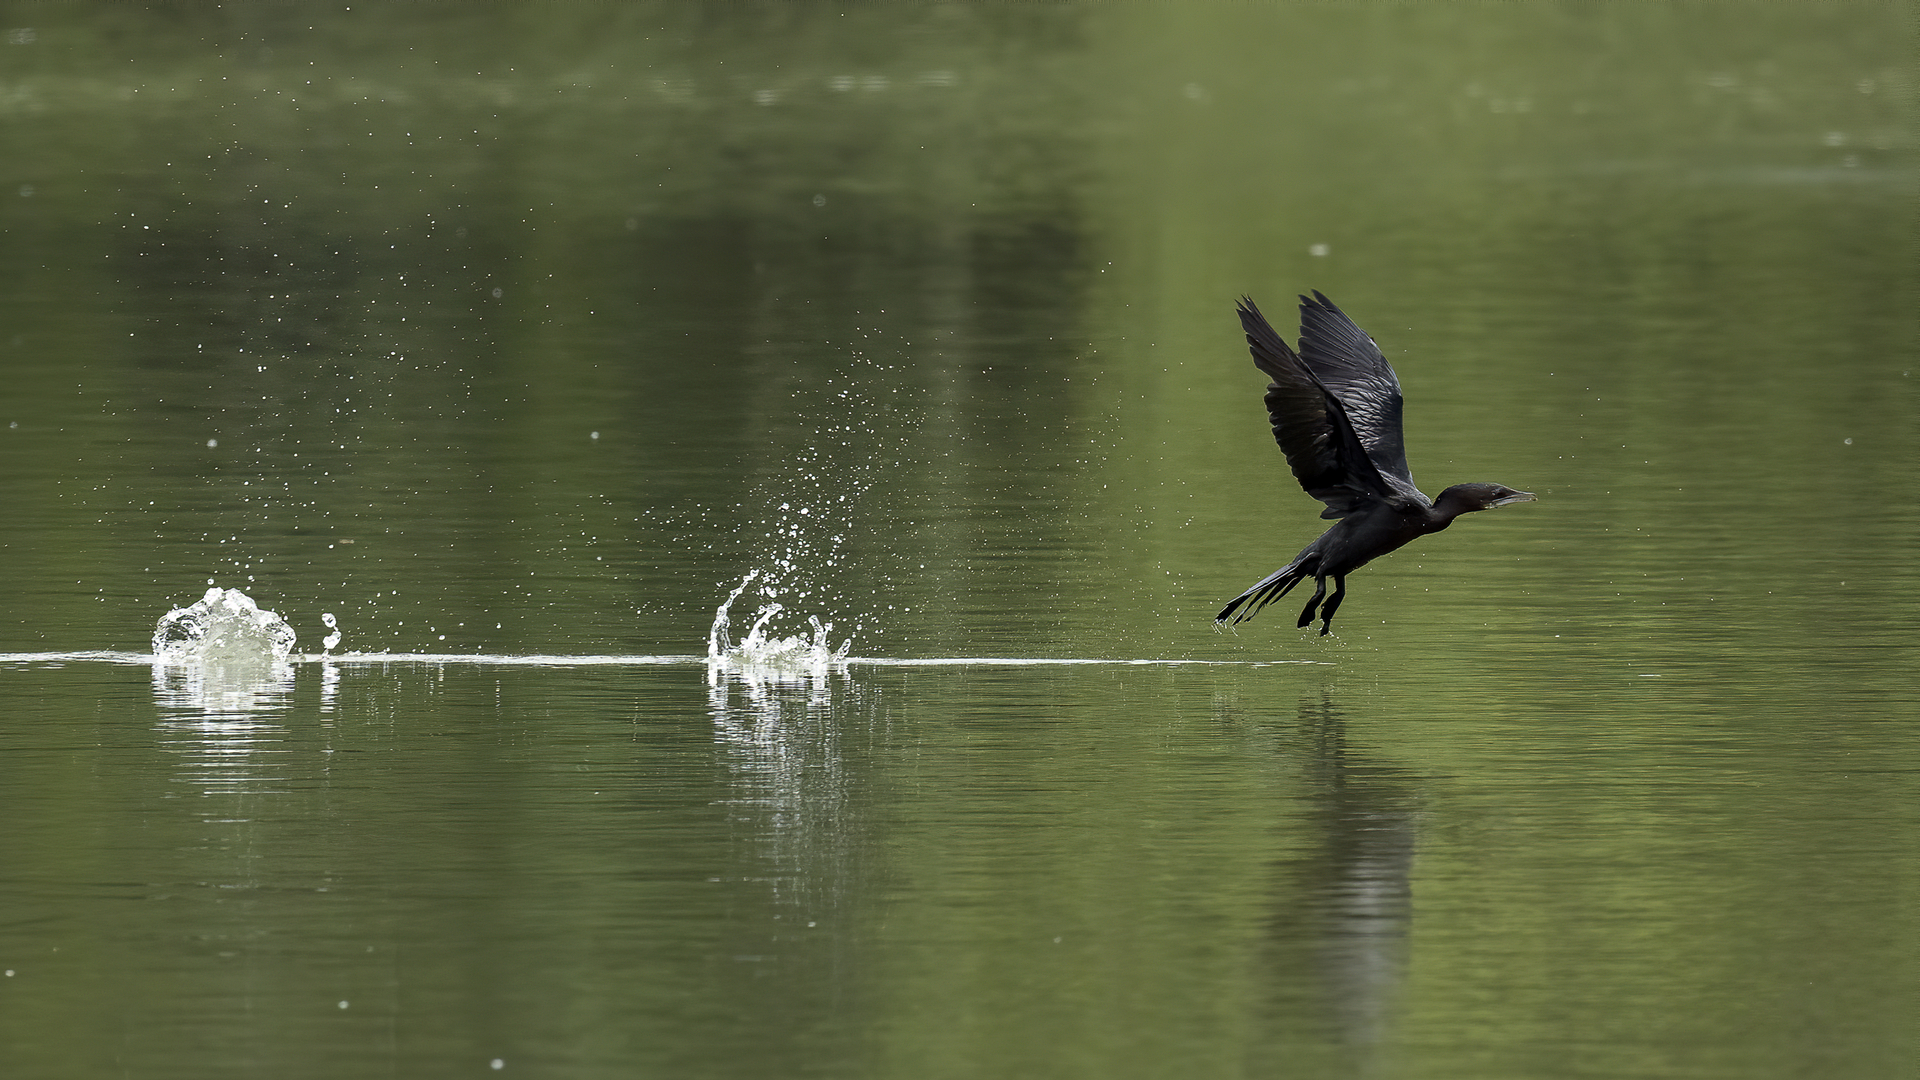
[1267, 687, 1419, 1065]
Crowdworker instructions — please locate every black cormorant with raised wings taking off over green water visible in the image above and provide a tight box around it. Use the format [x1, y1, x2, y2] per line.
[1213, 290, 1534, 636]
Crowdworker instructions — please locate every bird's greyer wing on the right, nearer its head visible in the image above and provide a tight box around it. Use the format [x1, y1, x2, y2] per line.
[1300, 290, 1427, 503]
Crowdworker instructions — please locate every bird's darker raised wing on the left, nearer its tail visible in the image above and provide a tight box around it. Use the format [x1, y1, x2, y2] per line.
[1238, 296, 1427, 517]
